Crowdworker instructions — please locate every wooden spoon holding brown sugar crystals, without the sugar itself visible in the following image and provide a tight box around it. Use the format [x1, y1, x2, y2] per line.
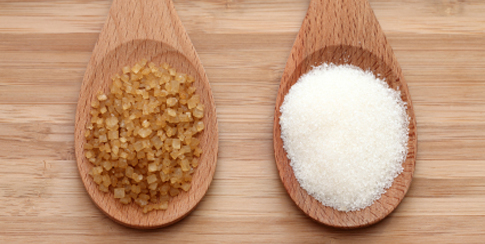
[75, 0, 218, 229]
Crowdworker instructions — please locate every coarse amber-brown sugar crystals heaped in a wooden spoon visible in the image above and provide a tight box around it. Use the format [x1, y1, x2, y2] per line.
[84, 59, 204, 213]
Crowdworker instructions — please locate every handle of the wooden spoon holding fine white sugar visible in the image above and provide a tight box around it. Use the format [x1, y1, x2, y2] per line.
[284, 0, 402, 82]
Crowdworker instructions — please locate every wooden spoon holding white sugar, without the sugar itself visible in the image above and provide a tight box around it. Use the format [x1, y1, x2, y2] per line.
[273, 0, 417, 228]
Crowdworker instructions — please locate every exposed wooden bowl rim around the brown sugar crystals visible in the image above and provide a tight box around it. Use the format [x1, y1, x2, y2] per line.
[75, 39, 219, 229]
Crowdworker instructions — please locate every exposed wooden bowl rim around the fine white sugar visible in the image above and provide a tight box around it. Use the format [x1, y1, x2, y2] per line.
[273, 44, 417, 229]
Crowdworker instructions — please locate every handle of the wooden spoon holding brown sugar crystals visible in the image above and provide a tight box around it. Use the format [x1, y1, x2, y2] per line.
[93, 0, 195, 65]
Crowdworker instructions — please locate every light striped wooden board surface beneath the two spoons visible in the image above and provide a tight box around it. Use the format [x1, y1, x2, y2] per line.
[0, 0, 485, 243]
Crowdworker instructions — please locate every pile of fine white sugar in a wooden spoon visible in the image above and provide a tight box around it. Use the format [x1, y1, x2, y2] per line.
[280, 64, 409, 211]
